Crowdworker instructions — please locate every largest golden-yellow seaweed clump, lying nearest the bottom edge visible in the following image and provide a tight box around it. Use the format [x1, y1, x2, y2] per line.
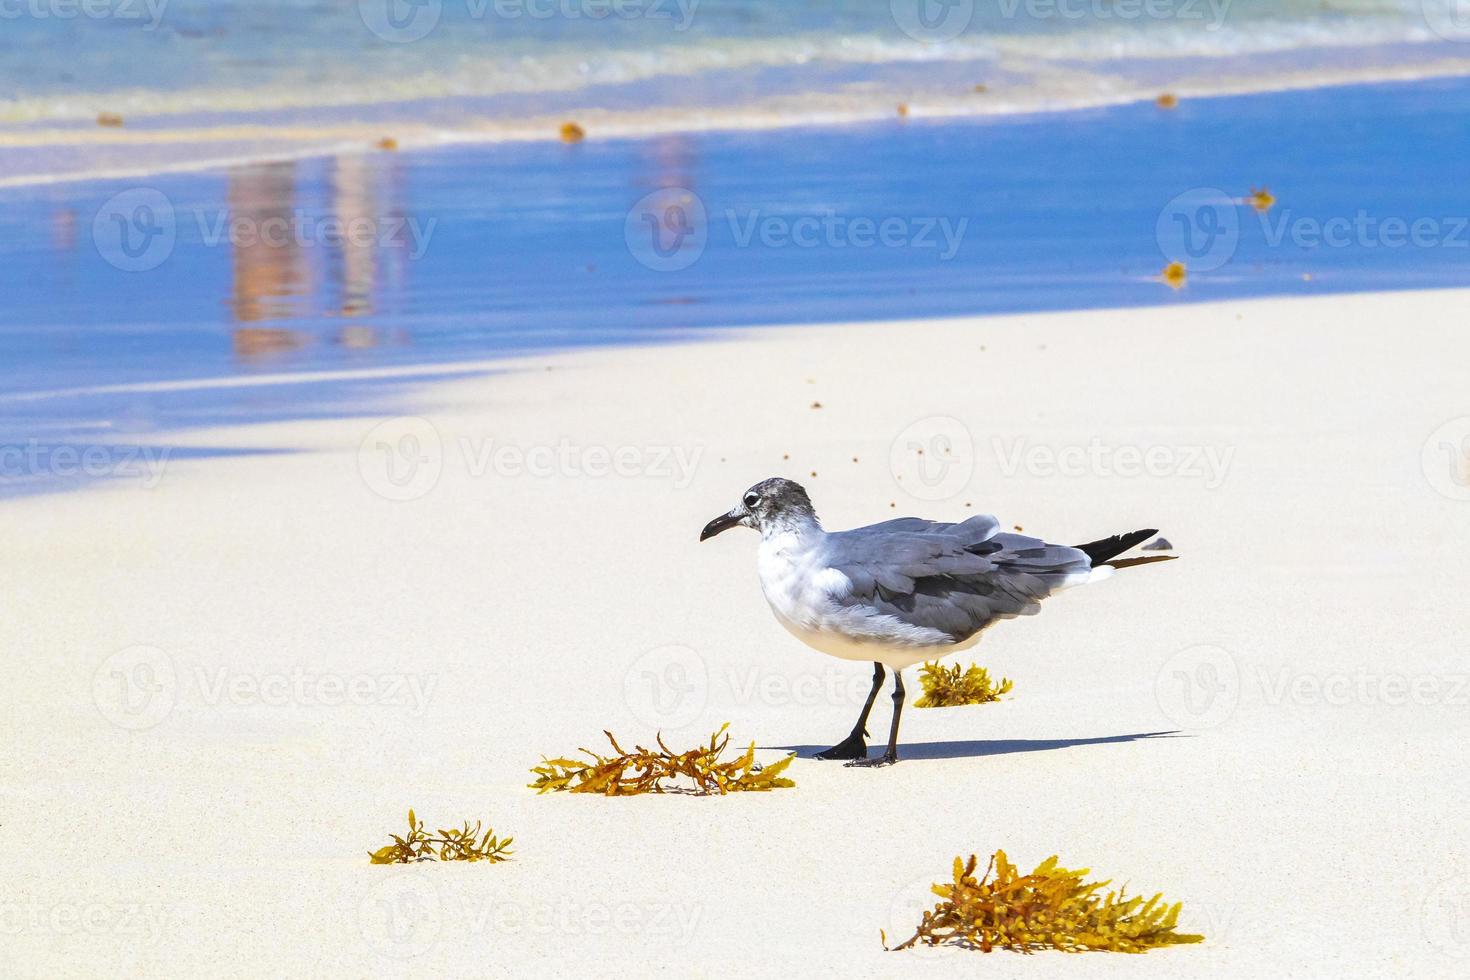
[881, 851, 1204, 952]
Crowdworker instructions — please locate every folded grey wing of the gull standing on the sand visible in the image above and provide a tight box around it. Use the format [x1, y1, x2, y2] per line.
[828, 516, 1092, 642]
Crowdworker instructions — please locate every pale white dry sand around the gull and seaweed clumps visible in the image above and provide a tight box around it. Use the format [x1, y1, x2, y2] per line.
[0, 292, 1470, 977]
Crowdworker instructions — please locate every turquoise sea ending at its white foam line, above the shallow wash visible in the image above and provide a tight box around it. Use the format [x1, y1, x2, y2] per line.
[0, 0, 1446, 120]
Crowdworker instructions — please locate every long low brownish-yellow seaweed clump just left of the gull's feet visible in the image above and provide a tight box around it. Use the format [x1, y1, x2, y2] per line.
[531, 721, 795, 796]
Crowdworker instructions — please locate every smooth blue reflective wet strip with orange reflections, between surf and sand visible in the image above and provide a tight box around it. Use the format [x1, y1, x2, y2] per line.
[0, 74, 1470, 499]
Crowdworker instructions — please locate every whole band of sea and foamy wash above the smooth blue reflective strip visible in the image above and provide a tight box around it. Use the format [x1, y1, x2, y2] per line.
[0, 0, 1470, 187]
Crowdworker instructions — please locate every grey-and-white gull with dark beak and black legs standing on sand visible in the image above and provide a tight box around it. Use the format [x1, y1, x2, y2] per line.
[700, 478, 1175, 765]
